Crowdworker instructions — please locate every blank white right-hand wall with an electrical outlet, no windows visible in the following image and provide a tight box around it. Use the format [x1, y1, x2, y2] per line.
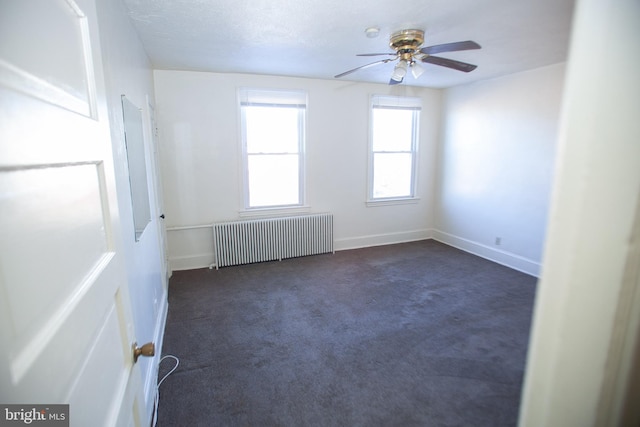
[434, 64, 565, 275]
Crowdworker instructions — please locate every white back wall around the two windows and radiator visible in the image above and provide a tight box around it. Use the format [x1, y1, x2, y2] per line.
[154, 70, 441, 269]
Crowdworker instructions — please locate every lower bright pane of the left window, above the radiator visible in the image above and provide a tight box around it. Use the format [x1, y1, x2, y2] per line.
[248, 154, 300, 207]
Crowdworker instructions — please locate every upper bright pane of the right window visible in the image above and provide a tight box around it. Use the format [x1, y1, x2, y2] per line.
[372, 108, 414, 151]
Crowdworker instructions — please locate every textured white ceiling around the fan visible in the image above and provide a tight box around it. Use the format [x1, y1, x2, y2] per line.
[124, 0, 574, 88]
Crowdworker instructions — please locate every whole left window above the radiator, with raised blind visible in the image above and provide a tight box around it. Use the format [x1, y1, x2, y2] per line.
[240, 89, 306, 209]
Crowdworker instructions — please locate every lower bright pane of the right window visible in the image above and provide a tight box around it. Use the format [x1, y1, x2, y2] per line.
[373, 153, 412, 198]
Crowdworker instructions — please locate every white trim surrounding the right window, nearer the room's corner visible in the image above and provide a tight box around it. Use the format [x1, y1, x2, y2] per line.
[365, 95, 422, 207]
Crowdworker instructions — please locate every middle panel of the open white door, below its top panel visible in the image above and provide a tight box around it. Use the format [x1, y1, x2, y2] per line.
[0, 164, 110, 338]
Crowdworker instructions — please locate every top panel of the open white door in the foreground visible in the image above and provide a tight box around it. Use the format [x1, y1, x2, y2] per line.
[0, 0, 94, 116]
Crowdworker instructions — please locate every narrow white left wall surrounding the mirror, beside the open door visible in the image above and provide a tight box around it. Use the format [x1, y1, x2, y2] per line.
[97, 1, 167, 420]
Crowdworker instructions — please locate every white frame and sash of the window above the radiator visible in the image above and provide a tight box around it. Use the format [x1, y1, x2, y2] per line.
[238, 88, 308, 216]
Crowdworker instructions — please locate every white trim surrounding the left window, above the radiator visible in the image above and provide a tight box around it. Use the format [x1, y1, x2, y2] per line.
[237, 87, 310, 212]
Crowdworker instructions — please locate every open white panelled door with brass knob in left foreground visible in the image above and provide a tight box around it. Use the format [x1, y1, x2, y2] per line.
[0, 0, 148, 426]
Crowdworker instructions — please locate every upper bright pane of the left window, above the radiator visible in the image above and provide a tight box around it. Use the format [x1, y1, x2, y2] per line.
[244, 106, 298, 153]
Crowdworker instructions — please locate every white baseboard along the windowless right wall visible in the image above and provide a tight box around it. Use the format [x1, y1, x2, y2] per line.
[432, 230, 541, 277]
